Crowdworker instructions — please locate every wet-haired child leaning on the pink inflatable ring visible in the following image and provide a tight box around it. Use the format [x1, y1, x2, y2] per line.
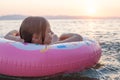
[5, 17, 83, 44]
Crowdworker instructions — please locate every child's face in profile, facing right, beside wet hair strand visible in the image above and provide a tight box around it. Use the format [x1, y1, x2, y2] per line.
[44, 26, 53, 44]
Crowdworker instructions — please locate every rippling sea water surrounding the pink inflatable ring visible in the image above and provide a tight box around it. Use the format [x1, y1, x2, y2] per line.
[0, 19, 120, 80]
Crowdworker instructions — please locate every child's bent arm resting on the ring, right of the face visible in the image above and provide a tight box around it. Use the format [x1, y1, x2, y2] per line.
[54, 33, 83, 44]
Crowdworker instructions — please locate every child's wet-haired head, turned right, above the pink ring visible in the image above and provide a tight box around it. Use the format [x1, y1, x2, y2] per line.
[19, 17, 53, 44]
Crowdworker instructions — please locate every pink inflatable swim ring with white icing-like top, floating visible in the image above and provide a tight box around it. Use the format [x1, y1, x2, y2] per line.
[0, 38, 101, 77]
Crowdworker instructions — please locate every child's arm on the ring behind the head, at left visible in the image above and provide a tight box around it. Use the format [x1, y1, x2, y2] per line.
[4, 30, 24, 42]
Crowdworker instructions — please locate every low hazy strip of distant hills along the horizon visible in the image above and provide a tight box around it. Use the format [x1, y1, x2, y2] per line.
[0, 14, 120, 20]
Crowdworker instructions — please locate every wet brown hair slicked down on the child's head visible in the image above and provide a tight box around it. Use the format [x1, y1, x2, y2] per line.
[19, 16, 50, 44]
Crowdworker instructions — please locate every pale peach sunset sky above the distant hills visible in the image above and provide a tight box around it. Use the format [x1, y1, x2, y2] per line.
[0, 0, 120, 17]
